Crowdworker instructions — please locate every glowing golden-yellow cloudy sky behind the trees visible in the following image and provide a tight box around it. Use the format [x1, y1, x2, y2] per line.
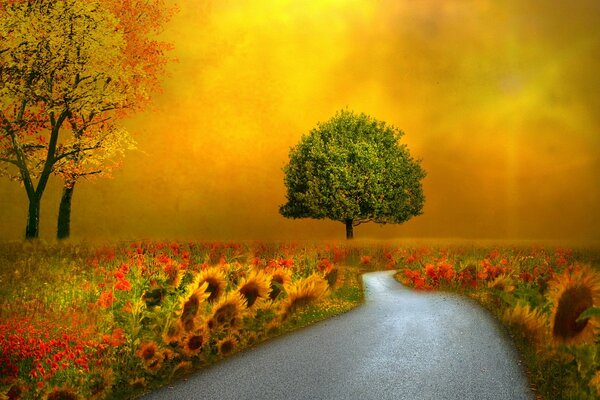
[0, 0, 600, 240]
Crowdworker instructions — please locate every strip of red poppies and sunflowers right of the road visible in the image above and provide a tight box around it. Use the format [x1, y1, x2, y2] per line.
[396, 247, 600, 400]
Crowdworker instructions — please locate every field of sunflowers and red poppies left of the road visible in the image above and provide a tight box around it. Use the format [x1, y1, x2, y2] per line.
[0, 243, 372, 399]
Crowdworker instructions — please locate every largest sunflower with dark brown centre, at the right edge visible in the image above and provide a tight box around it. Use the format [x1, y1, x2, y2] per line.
[548, 266, 600, 344]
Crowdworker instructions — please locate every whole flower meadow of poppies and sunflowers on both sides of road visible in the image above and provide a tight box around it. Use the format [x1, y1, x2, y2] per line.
[0, 241, 600, 400]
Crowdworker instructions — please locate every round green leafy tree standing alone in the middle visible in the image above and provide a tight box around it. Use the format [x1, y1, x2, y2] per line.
[279, 110, 426, 239]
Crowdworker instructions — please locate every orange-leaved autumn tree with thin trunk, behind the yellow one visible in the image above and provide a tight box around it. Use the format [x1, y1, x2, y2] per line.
[55, 0, 174, 239]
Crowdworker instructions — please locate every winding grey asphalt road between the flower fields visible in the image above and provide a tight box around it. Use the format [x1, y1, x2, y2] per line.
[144, 271, 534, 400]
